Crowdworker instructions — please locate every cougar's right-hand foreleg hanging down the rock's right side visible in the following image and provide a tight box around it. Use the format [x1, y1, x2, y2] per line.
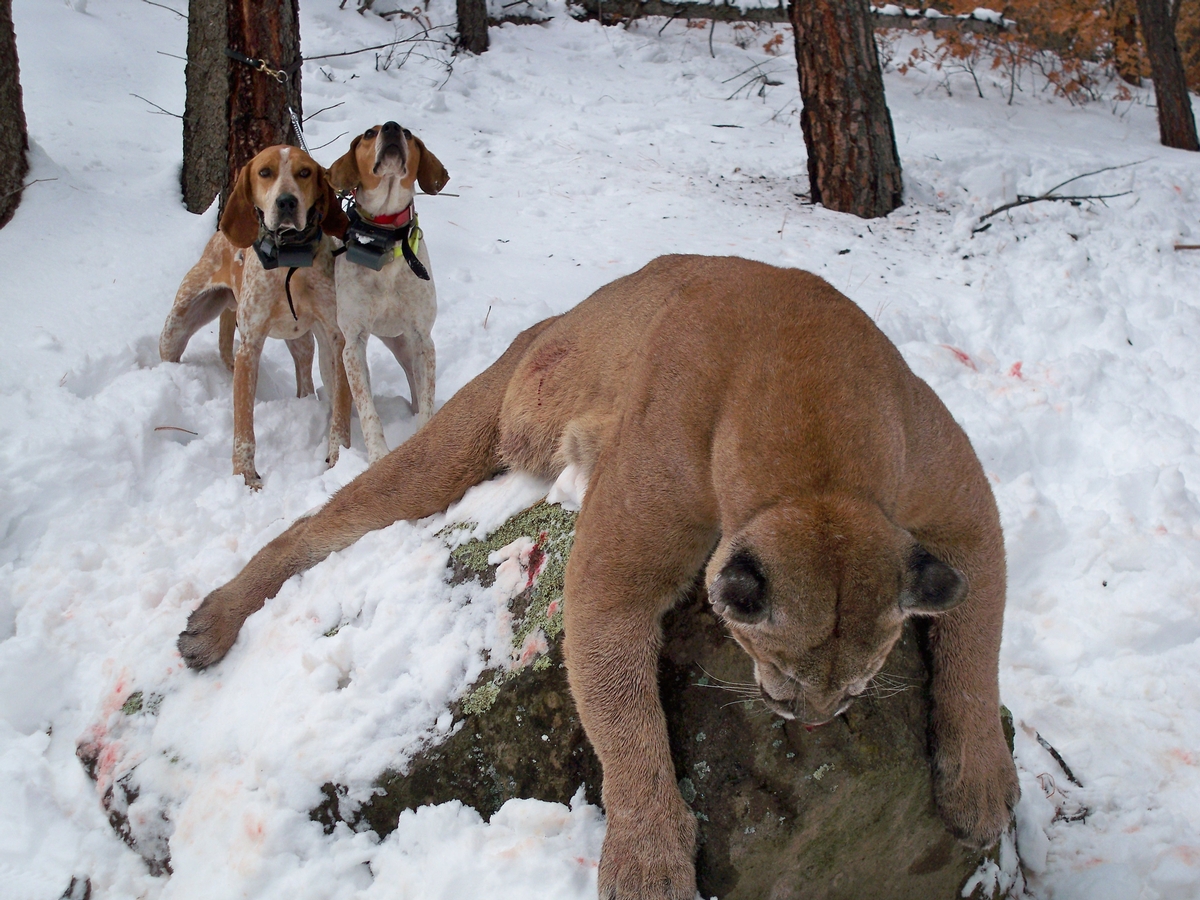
[929, 523, 1020, 847]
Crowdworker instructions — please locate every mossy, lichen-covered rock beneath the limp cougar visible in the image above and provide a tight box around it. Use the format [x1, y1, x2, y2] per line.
[313, 504, 1017, 900]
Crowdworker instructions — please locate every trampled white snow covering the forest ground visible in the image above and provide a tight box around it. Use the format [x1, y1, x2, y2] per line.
[7, 0, 1200, 900]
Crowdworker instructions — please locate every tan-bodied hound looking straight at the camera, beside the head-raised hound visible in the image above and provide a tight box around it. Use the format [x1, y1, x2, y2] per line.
[158, 146, 350, 488]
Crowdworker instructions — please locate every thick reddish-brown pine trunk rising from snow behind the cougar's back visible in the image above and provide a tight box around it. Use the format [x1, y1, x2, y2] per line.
[791, 0, 904, 218]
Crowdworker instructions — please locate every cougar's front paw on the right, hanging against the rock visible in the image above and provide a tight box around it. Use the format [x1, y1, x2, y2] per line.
[934, 728, 1021, 848]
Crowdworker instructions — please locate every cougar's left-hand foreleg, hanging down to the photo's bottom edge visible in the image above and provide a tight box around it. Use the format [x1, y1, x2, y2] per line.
[559, 468, 715, 900]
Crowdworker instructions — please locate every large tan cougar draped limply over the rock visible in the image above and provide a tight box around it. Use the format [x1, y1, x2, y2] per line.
[179, 257, 1018, 900]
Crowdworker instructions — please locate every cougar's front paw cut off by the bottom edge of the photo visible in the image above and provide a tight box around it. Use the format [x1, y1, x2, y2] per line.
[600, 800, 696, 900]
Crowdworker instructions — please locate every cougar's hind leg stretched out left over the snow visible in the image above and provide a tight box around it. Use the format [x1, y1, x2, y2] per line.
[179, 319, 552, 668]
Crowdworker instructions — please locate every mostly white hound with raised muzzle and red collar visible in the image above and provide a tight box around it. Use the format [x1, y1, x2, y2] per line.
[329, 122, 450, 463]
